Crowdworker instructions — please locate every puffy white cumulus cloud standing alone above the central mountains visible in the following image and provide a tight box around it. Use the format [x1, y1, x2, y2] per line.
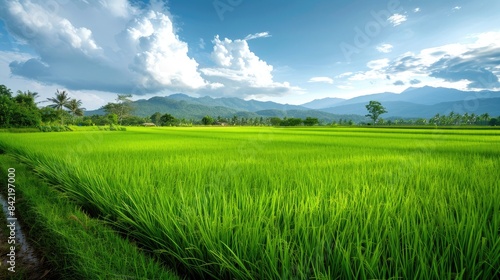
[200, 35, 301, 97]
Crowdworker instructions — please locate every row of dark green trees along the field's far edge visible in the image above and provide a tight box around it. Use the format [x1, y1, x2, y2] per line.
[0, 85, 500, 128]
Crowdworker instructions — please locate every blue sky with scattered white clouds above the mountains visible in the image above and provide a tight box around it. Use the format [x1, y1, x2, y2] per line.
[0, 0, 500, 110]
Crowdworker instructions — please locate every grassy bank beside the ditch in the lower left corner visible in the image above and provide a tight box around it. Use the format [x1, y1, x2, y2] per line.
[0, 155, 181, 279]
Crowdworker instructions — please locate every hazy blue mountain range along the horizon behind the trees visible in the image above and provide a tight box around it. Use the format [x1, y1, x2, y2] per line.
[86, 87, 500, 122]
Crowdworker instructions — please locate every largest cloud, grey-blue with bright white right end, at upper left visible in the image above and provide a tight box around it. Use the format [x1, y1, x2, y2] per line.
[0, 0, 208, 94]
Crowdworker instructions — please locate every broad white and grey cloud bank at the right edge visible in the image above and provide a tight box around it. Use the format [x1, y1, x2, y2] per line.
[339, 32, 500, 91]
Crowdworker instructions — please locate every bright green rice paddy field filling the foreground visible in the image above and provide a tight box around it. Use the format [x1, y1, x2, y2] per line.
[0, 127, 500, 279]
